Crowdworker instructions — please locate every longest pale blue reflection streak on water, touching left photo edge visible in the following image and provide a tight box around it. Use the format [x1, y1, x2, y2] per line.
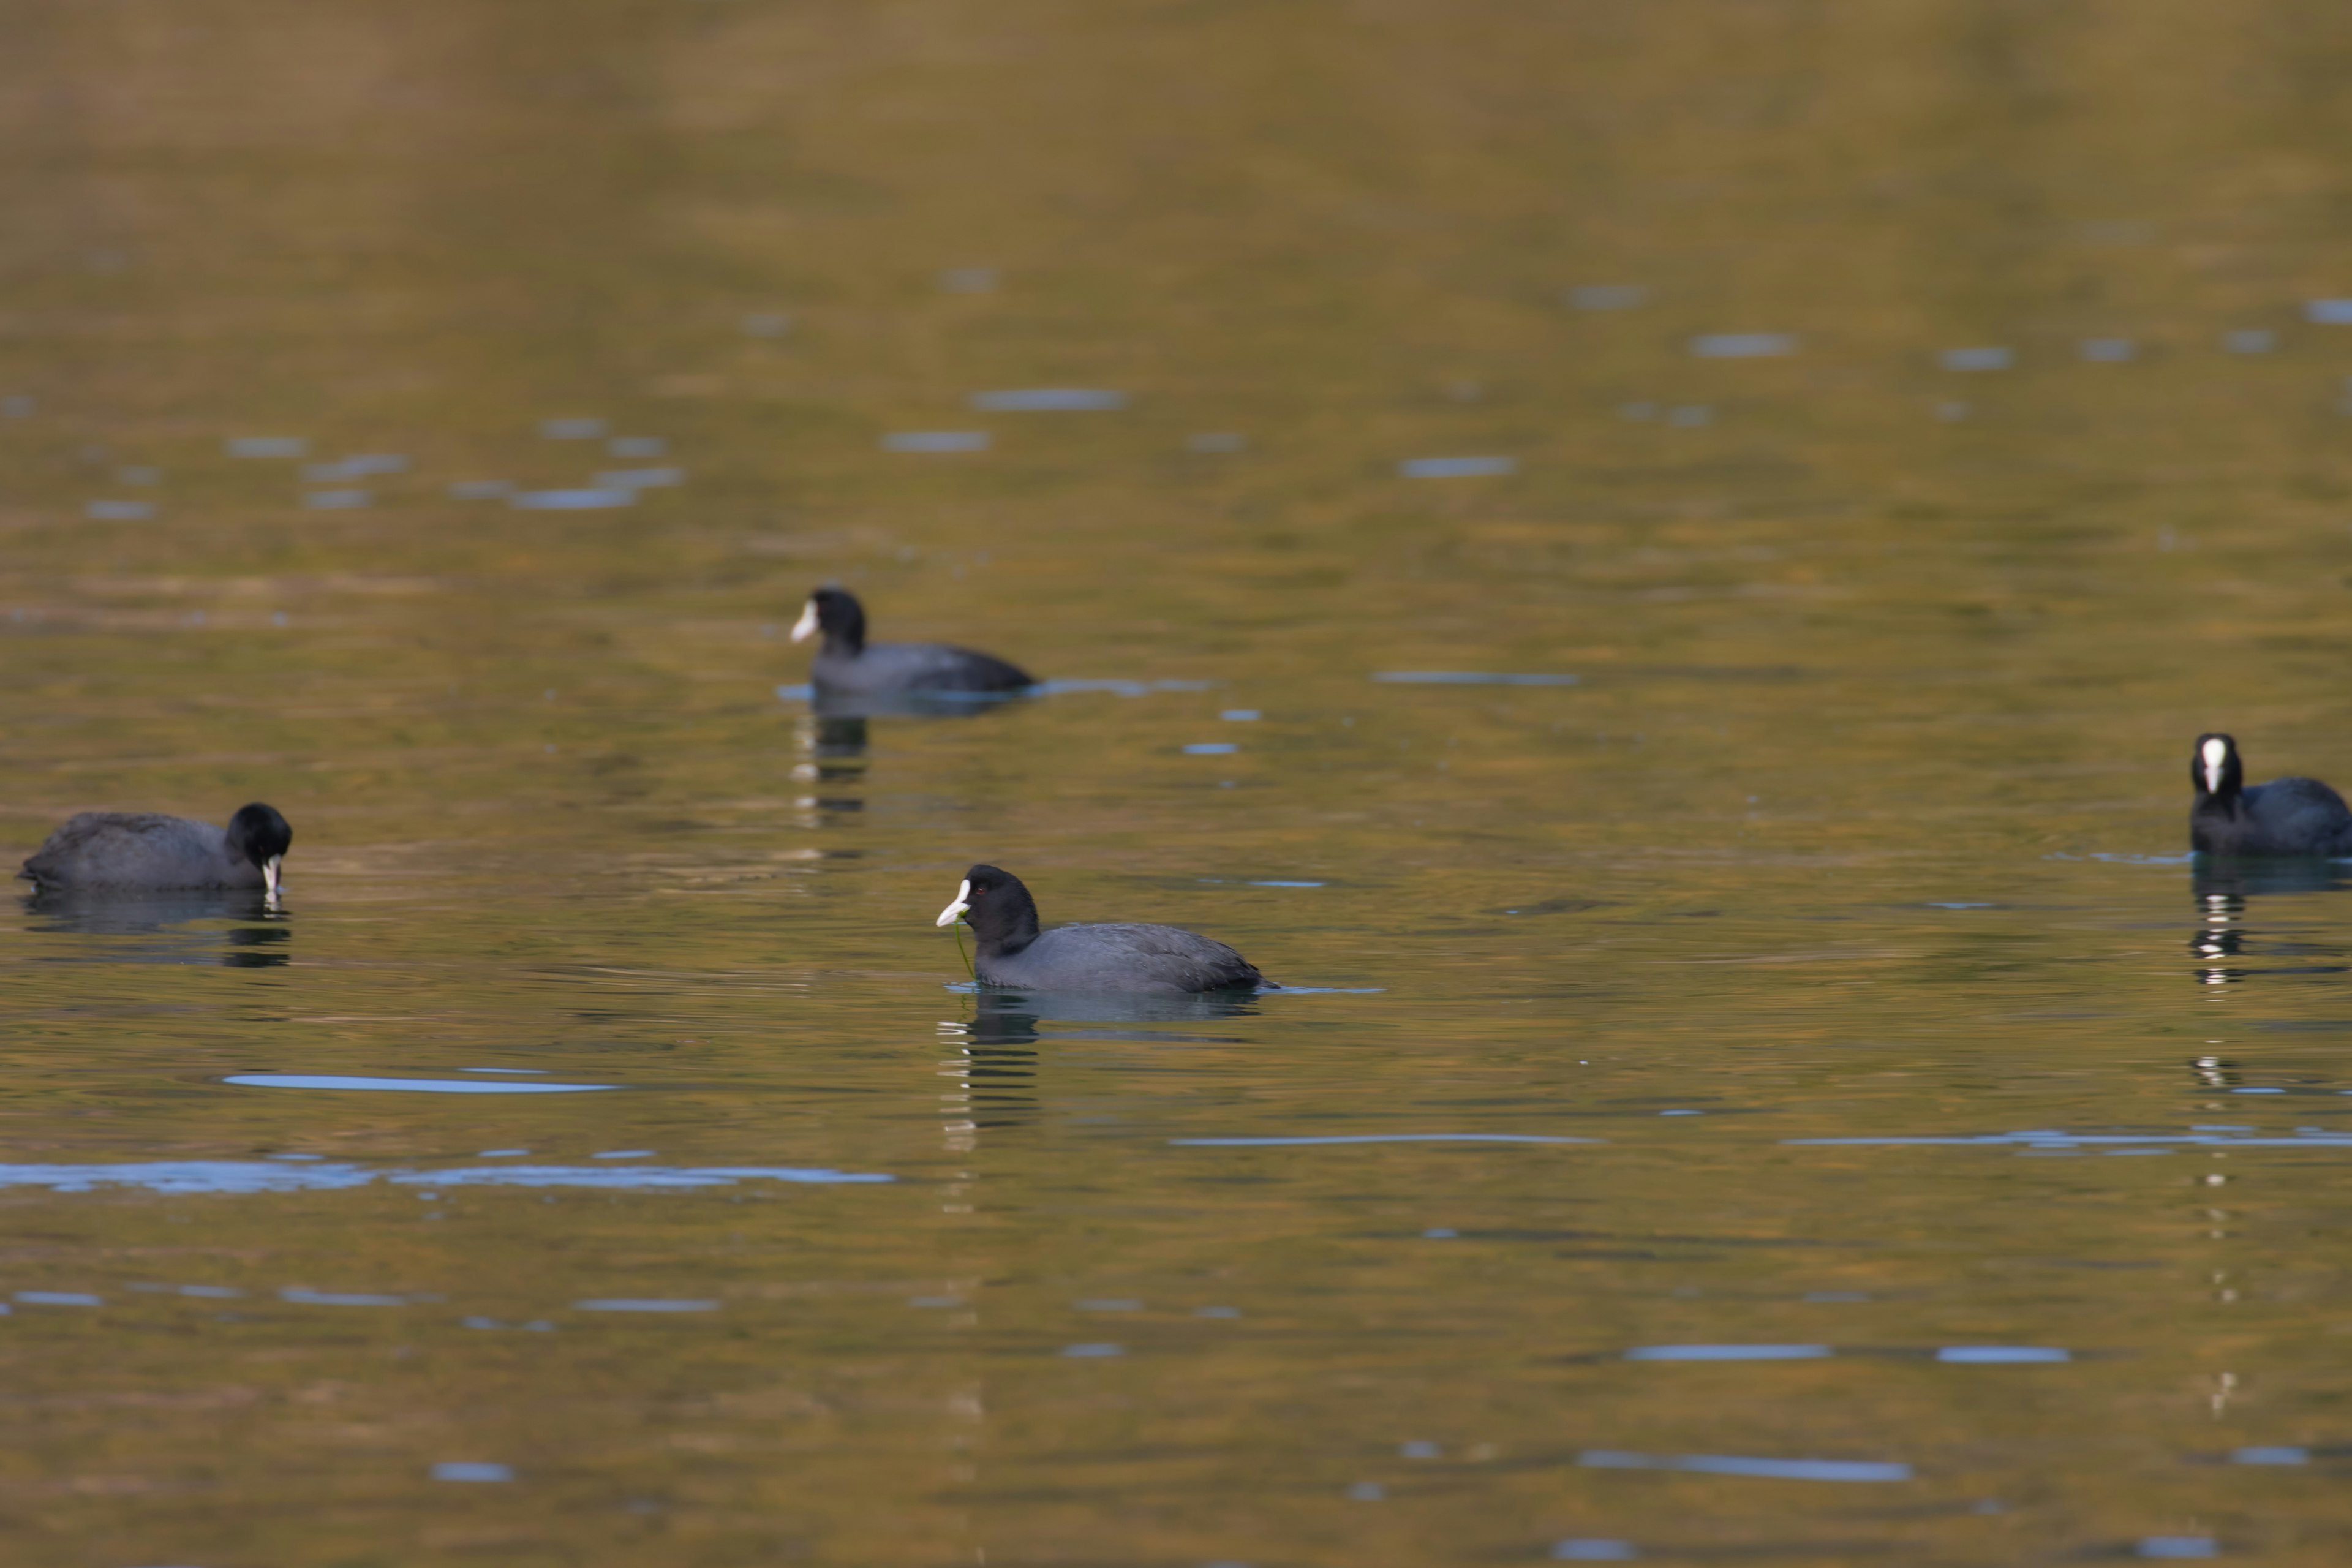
[0, 1159, 896, 1194]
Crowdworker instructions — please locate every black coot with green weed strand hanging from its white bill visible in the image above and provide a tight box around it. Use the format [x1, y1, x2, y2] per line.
[938, 865, 1280, 992]
